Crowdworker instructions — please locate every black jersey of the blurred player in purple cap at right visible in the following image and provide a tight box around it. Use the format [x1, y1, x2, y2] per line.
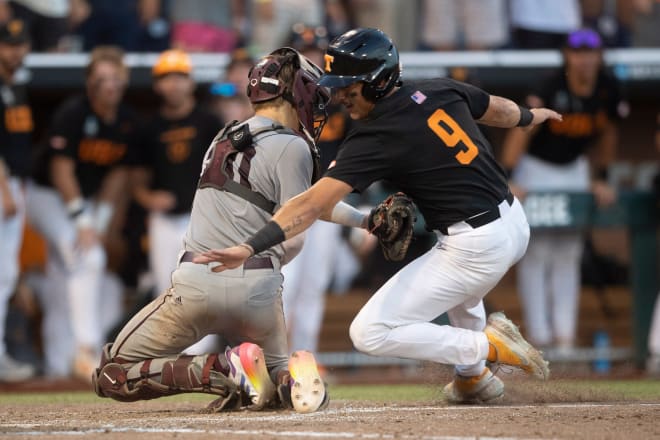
[528, 70, 627, 164]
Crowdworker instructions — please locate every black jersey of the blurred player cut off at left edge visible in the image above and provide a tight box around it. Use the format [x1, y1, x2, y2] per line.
[0, 82, 34, 177]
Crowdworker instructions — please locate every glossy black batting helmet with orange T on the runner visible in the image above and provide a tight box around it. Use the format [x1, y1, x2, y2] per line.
[319, 28, 401, 101]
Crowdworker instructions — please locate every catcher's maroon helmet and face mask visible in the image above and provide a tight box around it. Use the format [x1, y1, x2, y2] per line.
[247, 47, 330, 141]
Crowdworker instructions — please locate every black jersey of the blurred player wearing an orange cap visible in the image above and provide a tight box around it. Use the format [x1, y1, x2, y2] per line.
[139, 105, 222, 214]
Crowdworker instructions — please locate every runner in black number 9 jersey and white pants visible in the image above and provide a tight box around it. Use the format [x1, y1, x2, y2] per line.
[194, 29, 561, 403]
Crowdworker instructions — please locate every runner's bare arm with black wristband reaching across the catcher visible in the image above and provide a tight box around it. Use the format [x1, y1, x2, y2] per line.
[193, 177, 353, 272]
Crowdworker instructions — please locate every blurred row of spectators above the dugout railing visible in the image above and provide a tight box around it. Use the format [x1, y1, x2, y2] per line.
[0, 0, 660, 54]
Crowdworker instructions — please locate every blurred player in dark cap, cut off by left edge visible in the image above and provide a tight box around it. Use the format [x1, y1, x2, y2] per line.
[0, 19, 34, 382]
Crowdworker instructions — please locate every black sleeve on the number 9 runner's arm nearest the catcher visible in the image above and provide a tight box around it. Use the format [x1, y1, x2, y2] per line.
[325, 132, 392, 192]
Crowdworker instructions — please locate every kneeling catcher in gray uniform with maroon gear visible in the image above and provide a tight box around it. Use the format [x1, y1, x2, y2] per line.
[92, 48, 363, 412]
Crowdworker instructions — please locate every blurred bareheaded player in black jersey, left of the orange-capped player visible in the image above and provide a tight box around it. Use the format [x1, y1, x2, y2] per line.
[27, 46, 136, 380]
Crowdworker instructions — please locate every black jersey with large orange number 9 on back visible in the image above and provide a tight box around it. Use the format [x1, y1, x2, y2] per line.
[326, 78, 509, 229]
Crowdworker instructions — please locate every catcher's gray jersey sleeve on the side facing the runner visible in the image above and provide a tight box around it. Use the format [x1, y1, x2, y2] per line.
[275, 137, 313, 205]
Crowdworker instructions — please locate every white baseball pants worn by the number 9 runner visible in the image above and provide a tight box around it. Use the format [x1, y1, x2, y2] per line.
[350, 199, 529, 376]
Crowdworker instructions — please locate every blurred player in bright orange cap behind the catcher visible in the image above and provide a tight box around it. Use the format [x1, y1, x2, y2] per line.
[133, 49, 222, 350]
